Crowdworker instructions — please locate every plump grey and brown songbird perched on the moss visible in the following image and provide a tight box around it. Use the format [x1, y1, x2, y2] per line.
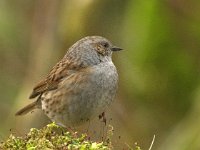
[15, 36, 122, 127]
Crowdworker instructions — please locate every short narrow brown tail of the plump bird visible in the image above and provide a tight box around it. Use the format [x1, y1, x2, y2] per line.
[15, 100, 41, 116]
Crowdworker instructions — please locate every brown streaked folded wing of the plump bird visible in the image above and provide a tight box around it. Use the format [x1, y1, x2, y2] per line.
[29, 59, 81, 99]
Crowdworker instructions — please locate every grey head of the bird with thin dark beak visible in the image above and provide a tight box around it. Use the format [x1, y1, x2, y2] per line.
[64, 36, 122, 66]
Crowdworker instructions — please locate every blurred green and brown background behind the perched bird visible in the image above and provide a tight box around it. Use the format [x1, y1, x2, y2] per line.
[0, 0, 200, 150]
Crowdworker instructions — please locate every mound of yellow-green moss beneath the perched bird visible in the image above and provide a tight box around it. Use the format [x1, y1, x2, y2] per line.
[0, 123, 109, 150]
